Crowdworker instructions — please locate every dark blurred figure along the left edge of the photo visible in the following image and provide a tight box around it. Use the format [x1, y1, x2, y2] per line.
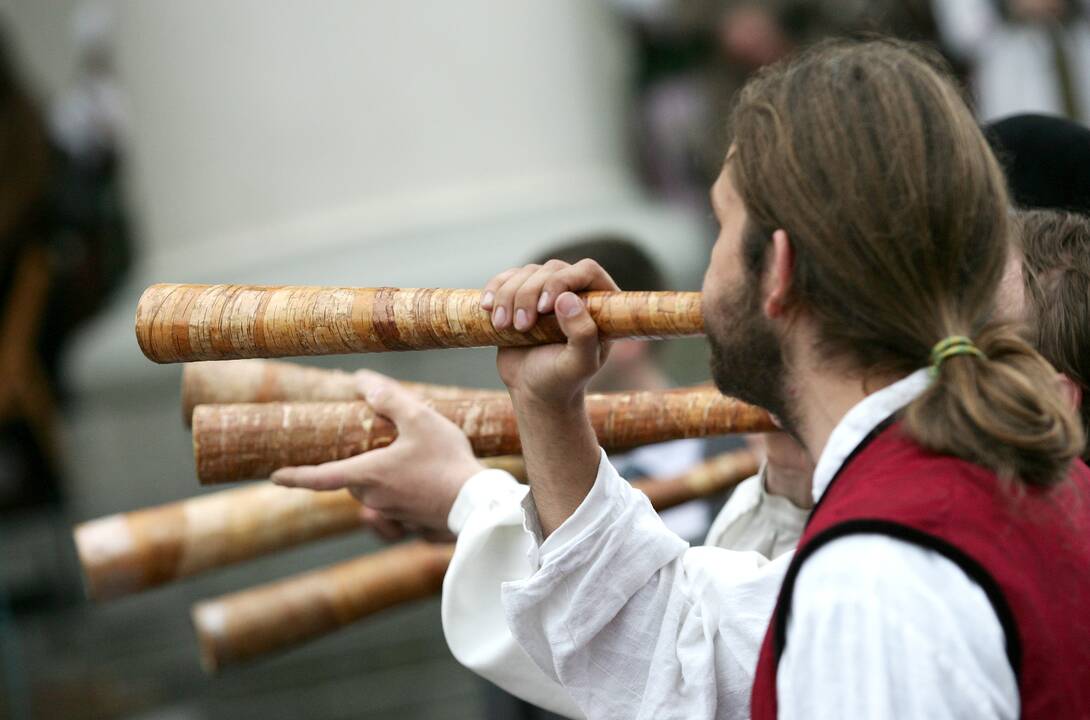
[0, 2, 130, 605]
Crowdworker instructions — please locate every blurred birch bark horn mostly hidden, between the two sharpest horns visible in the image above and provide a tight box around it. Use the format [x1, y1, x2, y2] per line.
[182, 359, 507, 426]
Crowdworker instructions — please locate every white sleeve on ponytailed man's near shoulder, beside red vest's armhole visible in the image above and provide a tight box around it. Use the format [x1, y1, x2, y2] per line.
[777, 535, 1019, 720]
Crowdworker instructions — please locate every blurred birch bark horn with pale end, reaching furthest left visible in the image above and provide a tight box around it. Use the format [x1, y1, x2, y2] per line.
[73, 456, 525, 601]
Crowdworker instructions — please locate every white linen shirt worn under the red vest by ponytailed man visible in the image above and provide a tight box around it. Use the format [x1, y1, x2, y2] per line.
[502, 370, 1019, 720]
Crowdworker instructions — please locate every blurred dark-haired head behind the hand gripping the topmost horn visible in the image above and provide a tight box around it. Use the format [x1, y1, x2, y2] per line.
[532, 234, 671, 392]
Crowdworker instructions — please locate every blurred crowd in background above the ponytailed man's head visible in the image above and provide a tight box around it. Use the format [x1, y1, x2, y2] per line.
[615, 0, 1090, 212]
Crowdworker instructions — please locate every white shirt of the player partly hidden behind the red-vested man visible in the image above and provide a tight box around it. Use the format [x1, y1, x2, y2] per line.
[443, 455, 807, 718]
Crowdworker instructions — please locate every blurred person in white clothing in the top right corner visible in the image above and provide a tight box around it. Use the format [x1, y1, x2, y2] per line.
[933, 0, 1090, 123]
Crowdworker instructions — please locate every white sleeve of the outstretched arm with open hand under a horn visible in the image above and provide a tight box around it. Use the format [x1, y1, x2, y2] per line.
[443, 469, 583, 718]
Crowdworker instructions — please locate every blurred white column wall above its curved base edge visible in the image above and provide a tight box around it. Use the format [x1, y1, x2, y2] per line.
[119, 0, 630, 277]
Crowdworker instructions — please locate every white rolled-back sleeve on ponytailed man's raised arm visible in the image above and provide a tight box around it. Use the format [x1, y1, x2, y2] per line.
[502, 453, 790, 720]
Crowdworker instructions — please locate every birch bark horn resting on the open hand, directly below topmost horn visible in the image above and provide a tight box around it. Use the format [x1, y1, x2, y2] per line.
[193, 388, 774, 485]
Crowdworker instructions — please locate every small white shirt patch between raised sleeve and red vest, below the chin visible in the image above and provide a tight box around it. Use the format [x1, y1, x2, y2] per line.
[704, 468, 810, 560]
